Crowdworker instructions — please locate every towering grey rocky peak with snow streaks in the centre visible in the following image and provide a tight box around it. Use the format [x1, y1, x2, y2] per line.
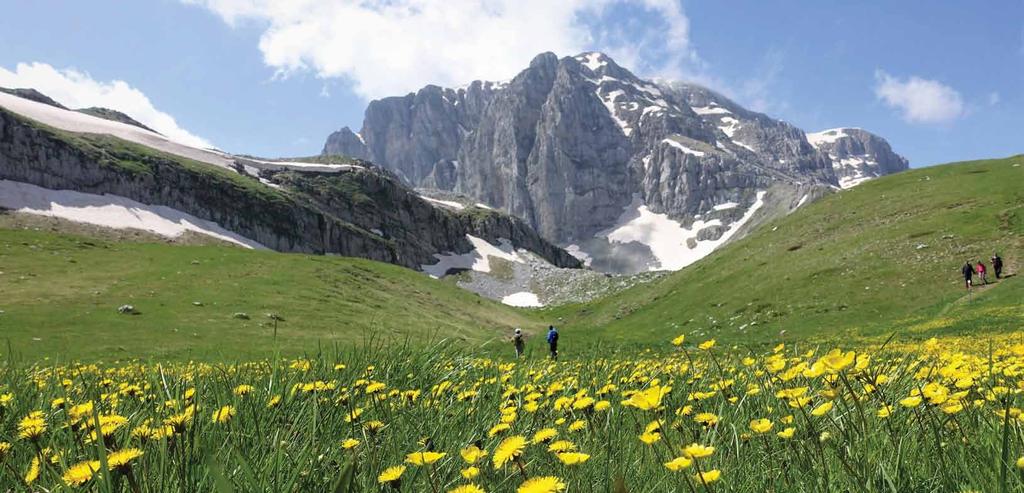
[324, 52, 905, 273]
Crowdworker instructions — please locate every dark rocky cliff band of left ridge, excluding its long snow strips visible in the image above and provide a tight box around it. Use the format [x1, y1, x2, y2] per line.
[0, 108, 579, 269]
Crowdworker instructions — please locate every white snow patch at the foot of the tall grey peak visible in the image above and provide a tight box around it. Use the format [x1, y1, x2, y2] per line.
[597, 191, 766, 271]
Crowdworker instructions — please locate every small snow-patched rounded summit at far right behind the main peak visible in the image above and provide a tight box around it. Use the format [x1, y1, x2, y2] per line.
[807, 128, 909, 189]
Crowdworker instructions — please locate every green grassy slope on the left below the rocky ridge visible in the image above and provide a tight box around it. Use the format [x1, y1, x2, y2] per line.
[0, 221, 529, 360]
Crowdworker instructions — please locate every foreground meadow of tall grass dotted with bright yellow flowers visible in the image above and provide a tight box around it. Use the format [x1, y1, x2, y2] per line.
[0, 335, 1024, 493]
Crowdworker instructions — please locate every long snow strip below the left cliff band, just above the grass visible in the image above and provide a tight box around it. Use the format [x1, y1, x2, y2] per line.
[0, 179, 266, 249]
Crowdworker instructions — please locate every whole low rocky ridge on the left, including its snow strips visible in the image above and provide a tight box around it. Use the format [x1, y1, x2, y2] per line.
[0, 92, 580, 274]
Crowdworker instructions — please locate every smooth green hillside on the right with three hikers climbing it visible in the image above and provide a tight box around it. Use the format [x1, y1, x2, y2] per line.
[548, 156, 1024, 342]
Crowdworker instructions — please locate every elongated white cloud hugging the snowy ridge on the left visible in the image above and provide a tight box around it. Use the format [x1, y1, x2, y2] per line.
[0, 63, 213, 148]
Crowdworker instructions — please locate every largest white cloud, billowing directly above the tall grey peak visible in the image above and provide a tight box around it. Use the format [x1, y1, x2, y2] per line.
[182, 0, 699, 98]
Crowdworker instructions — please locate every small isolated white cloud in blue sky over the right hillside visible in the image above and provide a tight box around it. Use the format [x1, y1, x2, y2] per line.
[874, 70, 966, 123]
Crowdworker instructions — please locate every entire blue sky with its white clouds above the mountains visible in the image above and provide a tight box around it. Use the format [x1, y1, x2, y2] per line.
[0, 0, 1024, 166]
